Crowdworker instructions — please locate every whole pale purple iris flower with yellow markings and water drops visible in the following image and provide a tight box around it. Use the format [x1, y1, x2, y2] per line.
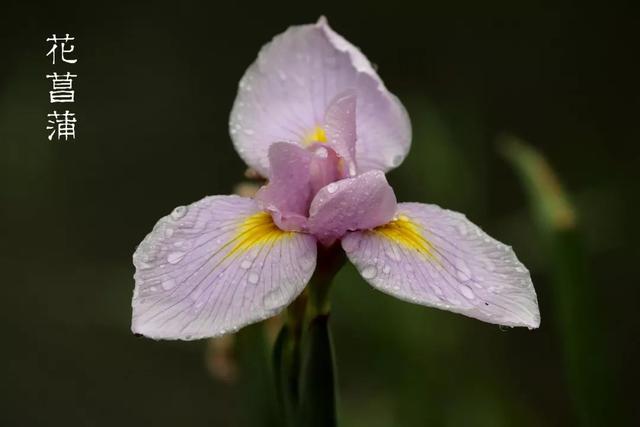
[132, 18, 540, 340]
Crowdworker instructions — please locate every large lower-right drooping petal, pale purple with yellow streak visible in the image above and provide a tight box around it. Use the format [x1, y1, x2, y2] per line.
[342, 203, 540, 328]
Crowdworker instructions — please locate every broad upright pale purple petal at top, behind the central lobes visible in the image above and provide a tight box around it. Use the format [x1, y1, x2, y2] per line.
[230, 19, 411, 176]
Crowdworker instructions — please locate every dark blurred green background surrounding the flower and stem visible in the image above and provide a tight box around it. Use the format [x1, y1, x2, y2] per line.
[0, 1, 640, 427]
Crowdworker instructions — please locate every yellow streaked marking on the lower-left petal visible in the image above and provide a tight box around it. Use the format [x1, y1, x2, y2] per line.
[224, 212, 293, 259]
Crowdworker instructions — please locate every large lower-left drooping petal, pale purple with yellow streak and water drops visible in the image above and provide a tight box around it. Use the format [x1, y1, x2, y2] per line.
[132, 196, 316, 340]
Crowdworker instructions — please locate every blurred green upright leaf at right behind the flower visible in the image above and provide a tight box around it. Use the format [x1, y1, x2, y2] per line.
[500, 136, 626, 426]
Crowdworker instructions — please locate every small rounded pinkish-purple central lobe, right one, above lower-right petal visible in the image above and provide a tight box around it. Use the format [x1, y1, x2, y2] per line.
[309, 171, 396, 245]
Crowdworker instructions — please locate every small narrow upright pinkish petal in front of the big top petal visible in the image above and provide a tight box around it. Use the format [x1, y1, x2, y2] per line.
[324, 90, 357, 176]
